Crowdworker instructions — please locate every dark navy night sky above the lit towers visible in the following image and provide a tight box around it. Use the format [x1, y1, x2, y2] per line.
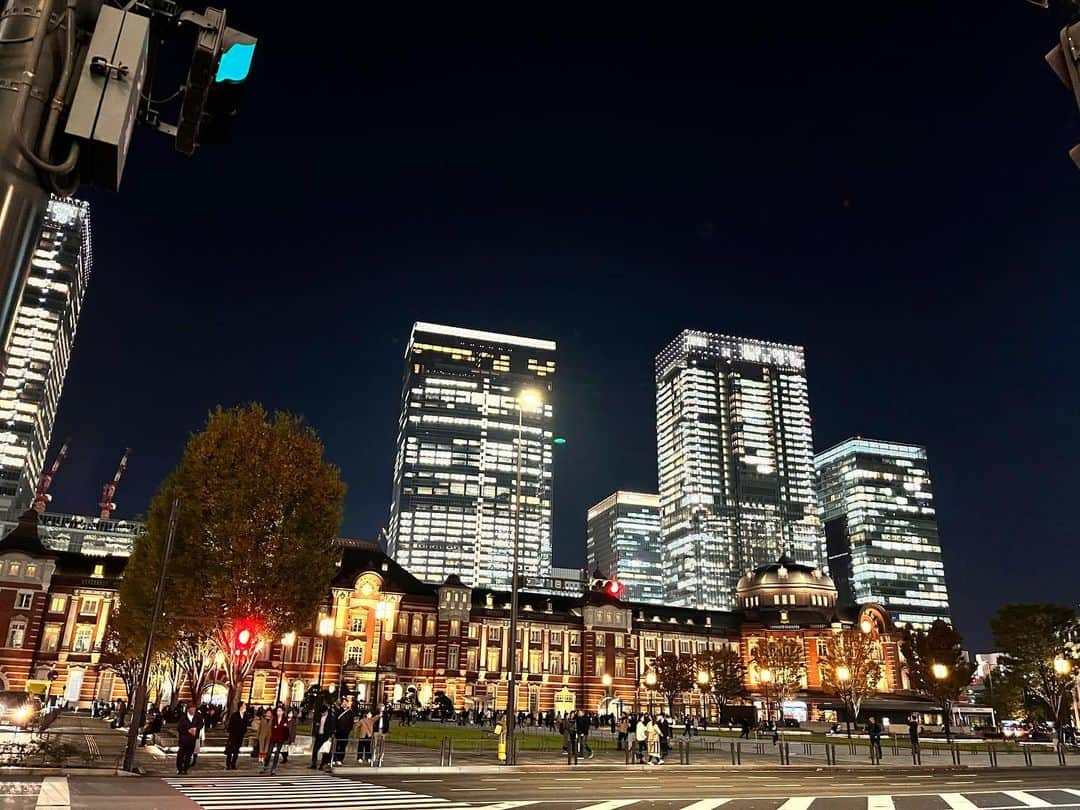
[42, 0, 1080, 651]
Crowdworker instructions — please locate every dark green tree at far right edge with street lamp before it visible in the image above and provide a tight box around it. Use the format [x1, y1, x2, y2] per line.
[990, 604, 1080, 726]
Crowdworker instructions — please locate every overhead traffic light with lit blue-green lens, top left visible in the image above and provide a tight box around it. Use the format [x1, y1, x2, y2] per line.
[176, 6, 258, 154]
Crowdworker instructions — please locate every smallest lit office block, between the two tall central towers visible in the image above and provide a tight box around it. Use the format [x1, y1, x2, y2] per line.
[585, 491, 664, 602]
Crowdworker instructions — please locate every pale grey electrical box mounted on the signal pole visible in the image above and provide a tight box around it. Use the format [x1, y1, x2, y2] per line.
[65, 5, 150, 191]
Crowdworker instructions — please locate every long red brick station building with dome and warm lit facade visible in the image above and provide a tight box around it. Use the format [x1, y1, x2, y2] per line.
[0, 511, 937, 721]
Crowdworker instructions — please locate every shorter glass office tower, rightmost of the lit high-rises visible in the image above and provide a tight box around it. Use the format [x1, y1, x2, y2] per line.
[814, 437, 950, 627]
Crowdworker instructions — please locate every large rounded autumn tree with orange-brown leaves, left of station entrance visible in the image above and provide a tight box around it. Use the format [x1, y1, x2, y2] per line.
[120, 405, 345, 702]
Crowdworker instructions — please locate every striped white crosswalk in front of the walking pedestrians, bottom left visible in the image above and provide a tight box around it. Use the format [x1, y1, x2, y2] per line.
[158, 774, 475, 810]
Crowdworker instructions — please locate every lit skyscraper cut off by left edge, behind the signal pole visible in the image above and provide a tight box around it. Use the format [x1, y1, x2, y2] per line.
[0, 198, 92, 515]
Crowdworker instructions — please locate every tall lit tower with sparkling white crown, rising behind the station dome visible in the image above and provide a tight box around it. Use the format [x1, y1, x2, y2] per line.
[656, 329, 825, 609]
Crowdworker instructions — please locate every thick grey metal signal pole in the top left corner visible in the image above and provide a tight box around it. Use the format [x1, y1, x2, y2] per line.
[0, 0, 75, 359]
